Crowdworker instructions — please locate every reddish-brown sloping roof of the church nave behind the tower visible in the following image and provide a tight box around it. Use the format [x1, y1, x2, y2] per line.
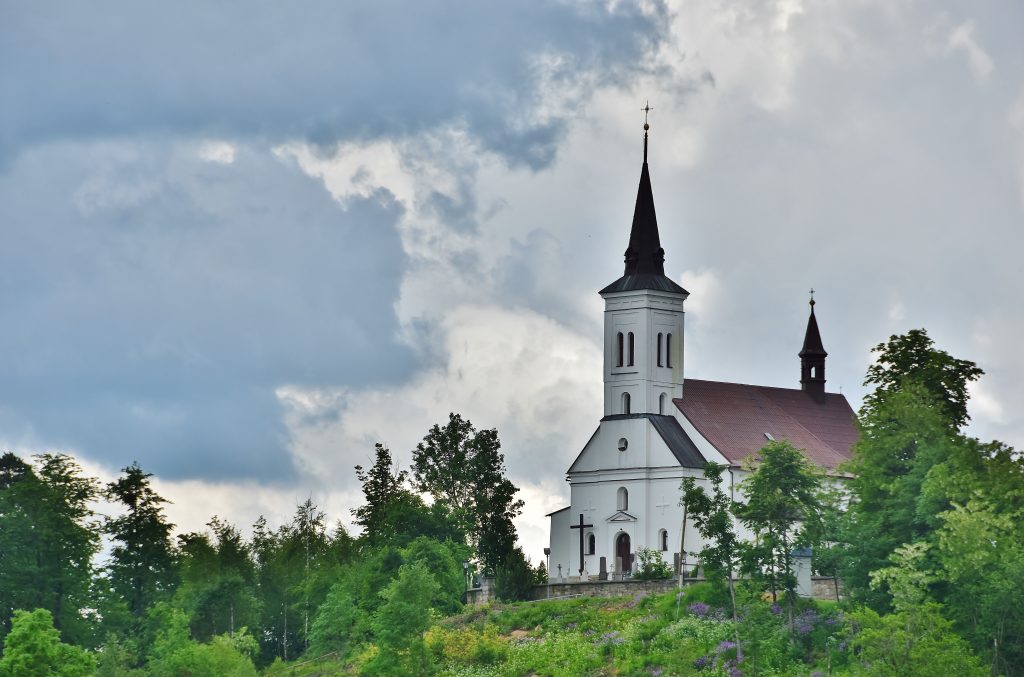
[674, 379, 858, 469]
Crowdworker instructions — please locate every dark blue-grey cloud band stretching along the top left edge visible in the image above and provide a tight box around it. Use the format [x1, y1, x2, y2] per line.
[0, 1, 667, 167]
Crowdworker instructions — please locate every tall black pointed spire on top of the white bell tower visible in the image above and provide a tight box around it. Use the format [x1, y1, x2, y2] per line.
[601, 113, 688, 295]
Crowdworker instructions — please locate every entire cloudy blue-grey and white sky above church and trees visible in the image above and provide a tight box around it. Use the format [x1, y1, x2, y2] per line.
[0, 0, 1024, 561]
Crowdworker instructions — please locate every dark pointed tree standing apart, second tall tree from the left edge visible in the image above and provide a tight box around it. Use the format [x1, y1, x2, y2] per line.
[104, 463, 177, 619]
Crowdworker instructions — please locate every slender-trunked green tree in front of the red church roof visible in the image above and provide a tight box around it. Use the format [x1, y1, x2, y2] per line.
[735, 440, 822, 630]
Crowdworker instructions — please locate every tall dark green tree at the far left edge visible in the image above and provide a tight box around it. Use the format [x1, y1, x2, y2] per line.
[0, 453, 99, 645]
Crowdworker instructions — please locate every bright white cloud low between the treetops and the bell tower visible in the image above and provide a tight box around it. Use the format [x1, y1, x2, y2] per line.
[278, 306, 602, 555]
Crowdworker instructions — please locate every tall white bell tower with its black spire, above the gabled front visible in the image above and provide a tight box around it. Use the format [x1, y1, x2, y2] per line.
[600, 116, 689, 417]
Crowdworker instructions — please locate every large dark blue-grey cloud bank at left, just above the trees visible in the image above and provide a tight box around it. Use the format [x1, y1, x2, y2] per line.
[0, 141, 414, 479]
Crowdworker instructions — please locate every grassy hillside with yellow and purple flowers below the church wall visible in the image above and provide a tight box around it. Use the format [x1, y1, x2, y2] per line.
[266, 586, 848, 677]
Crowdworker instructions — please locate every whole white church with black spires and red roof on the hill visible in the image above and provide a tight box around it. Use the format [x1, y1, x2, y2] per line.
[548, 124, 857, 581]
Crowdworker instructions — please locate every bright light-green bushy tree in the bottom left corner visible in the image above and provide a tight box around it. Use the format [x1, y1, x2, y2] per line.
[0, 608, 95, 677]
